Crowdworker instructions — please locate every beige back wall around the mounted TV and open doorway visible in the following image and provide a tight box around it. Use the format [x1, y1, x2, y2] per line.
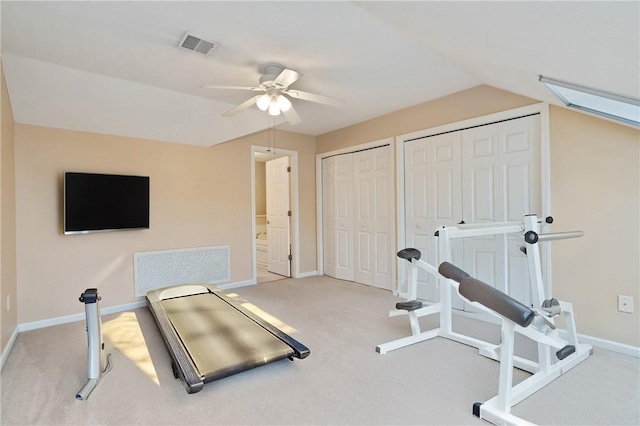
[15, 124, 315, 323]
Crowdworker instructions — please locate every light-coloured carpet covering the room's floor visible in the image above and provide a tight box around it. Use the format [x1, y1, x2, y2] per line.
[0, 277, 640, 425]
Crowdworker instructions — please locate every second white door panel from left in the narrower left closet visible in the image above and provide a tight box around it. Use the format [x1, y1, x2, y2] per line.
[334, 154, 355, 281]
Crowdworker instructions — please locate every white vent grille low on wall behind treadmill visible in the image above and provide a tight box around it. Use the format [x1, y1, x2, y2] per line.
[133, 246, 231, 297]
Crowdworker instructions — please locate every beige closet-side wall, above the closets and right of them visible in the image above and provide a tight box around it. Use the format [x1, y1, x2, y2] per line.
[316, 86, 640, 346]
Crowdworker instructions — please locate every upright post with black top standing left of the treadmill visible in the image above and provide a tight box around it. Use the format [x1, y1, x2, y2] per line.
[76, 288, 107, 401]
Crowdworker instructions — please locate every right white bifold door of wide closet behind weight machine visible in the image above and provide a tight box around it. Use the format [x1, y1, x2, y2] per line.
[462, 115, 541, 303]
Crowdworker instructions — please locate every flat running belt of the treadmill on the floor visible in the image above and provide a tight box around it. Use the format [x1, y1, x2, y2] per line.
[162, 294, 292, 379]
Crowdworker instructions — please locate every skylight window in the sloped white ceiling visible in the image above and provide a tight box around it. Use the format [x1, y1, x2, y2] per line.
[539, 76, 640, 127]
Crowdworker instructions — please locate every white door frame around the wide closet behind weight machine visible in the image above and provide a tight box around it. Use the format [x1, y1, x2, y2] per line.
[394, 102, 552, 294]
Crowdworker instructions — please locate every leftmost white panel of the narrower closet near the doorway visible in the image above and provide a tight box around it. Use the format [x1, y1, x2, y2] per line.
[322, 157, 336, 277]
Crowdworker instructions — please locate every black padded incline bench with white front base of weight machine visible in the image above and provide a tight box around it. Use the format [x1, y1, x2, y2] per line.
[439, 262, 588, 425]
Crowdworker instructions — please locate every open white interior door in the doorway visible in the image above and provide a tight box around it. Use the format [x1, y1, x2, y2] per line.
[266, 157, 291, 277]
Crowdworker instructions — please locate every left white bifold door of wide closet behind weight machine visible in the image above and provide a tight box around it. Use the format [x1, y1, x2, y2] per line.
[399, 132, 462, 301]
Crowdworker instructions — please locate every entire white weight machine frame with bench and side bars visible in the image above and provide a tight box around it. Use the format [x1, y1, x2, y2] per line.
[376, 215, 593, 424]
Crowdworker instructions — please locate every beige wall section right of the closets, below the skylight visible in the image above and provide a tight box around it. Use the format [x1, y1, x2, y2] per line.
[550, 107, 640, 346]
